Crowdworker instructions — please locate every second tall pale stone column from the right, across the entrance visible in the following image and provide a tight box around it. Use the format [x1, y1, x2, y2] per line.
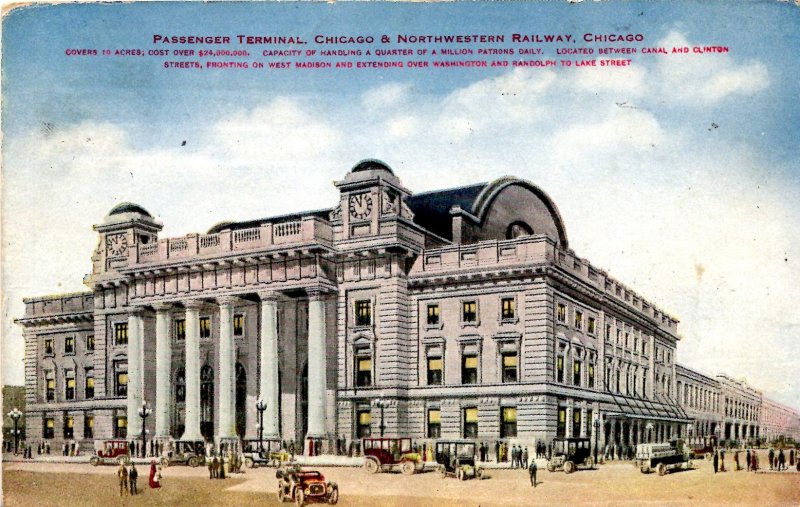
[258, 292, 282, 438]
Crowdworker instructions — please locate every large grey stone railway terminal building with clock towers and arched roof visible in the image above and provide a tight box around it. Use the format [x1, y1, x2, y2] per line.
[17, 160, 800, 451]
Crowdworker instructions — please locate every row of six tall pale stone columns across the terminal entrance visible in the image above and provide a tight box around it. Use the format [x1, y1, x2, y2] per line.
[126, 291, 327, 446]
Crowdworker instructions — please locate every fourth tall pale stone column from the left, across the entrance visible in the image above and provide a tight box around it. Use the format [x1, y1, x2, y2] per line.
[216, 297, 237, 439]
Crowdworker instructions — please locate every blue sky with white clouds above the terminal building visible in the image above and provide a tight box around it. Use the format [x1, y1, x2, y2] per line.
[2, 1, 800, 407]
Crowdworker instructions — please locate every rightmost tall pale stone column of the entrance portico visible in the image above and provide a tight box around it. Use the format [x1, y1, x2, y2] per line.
[306, 291, 327, 438]
